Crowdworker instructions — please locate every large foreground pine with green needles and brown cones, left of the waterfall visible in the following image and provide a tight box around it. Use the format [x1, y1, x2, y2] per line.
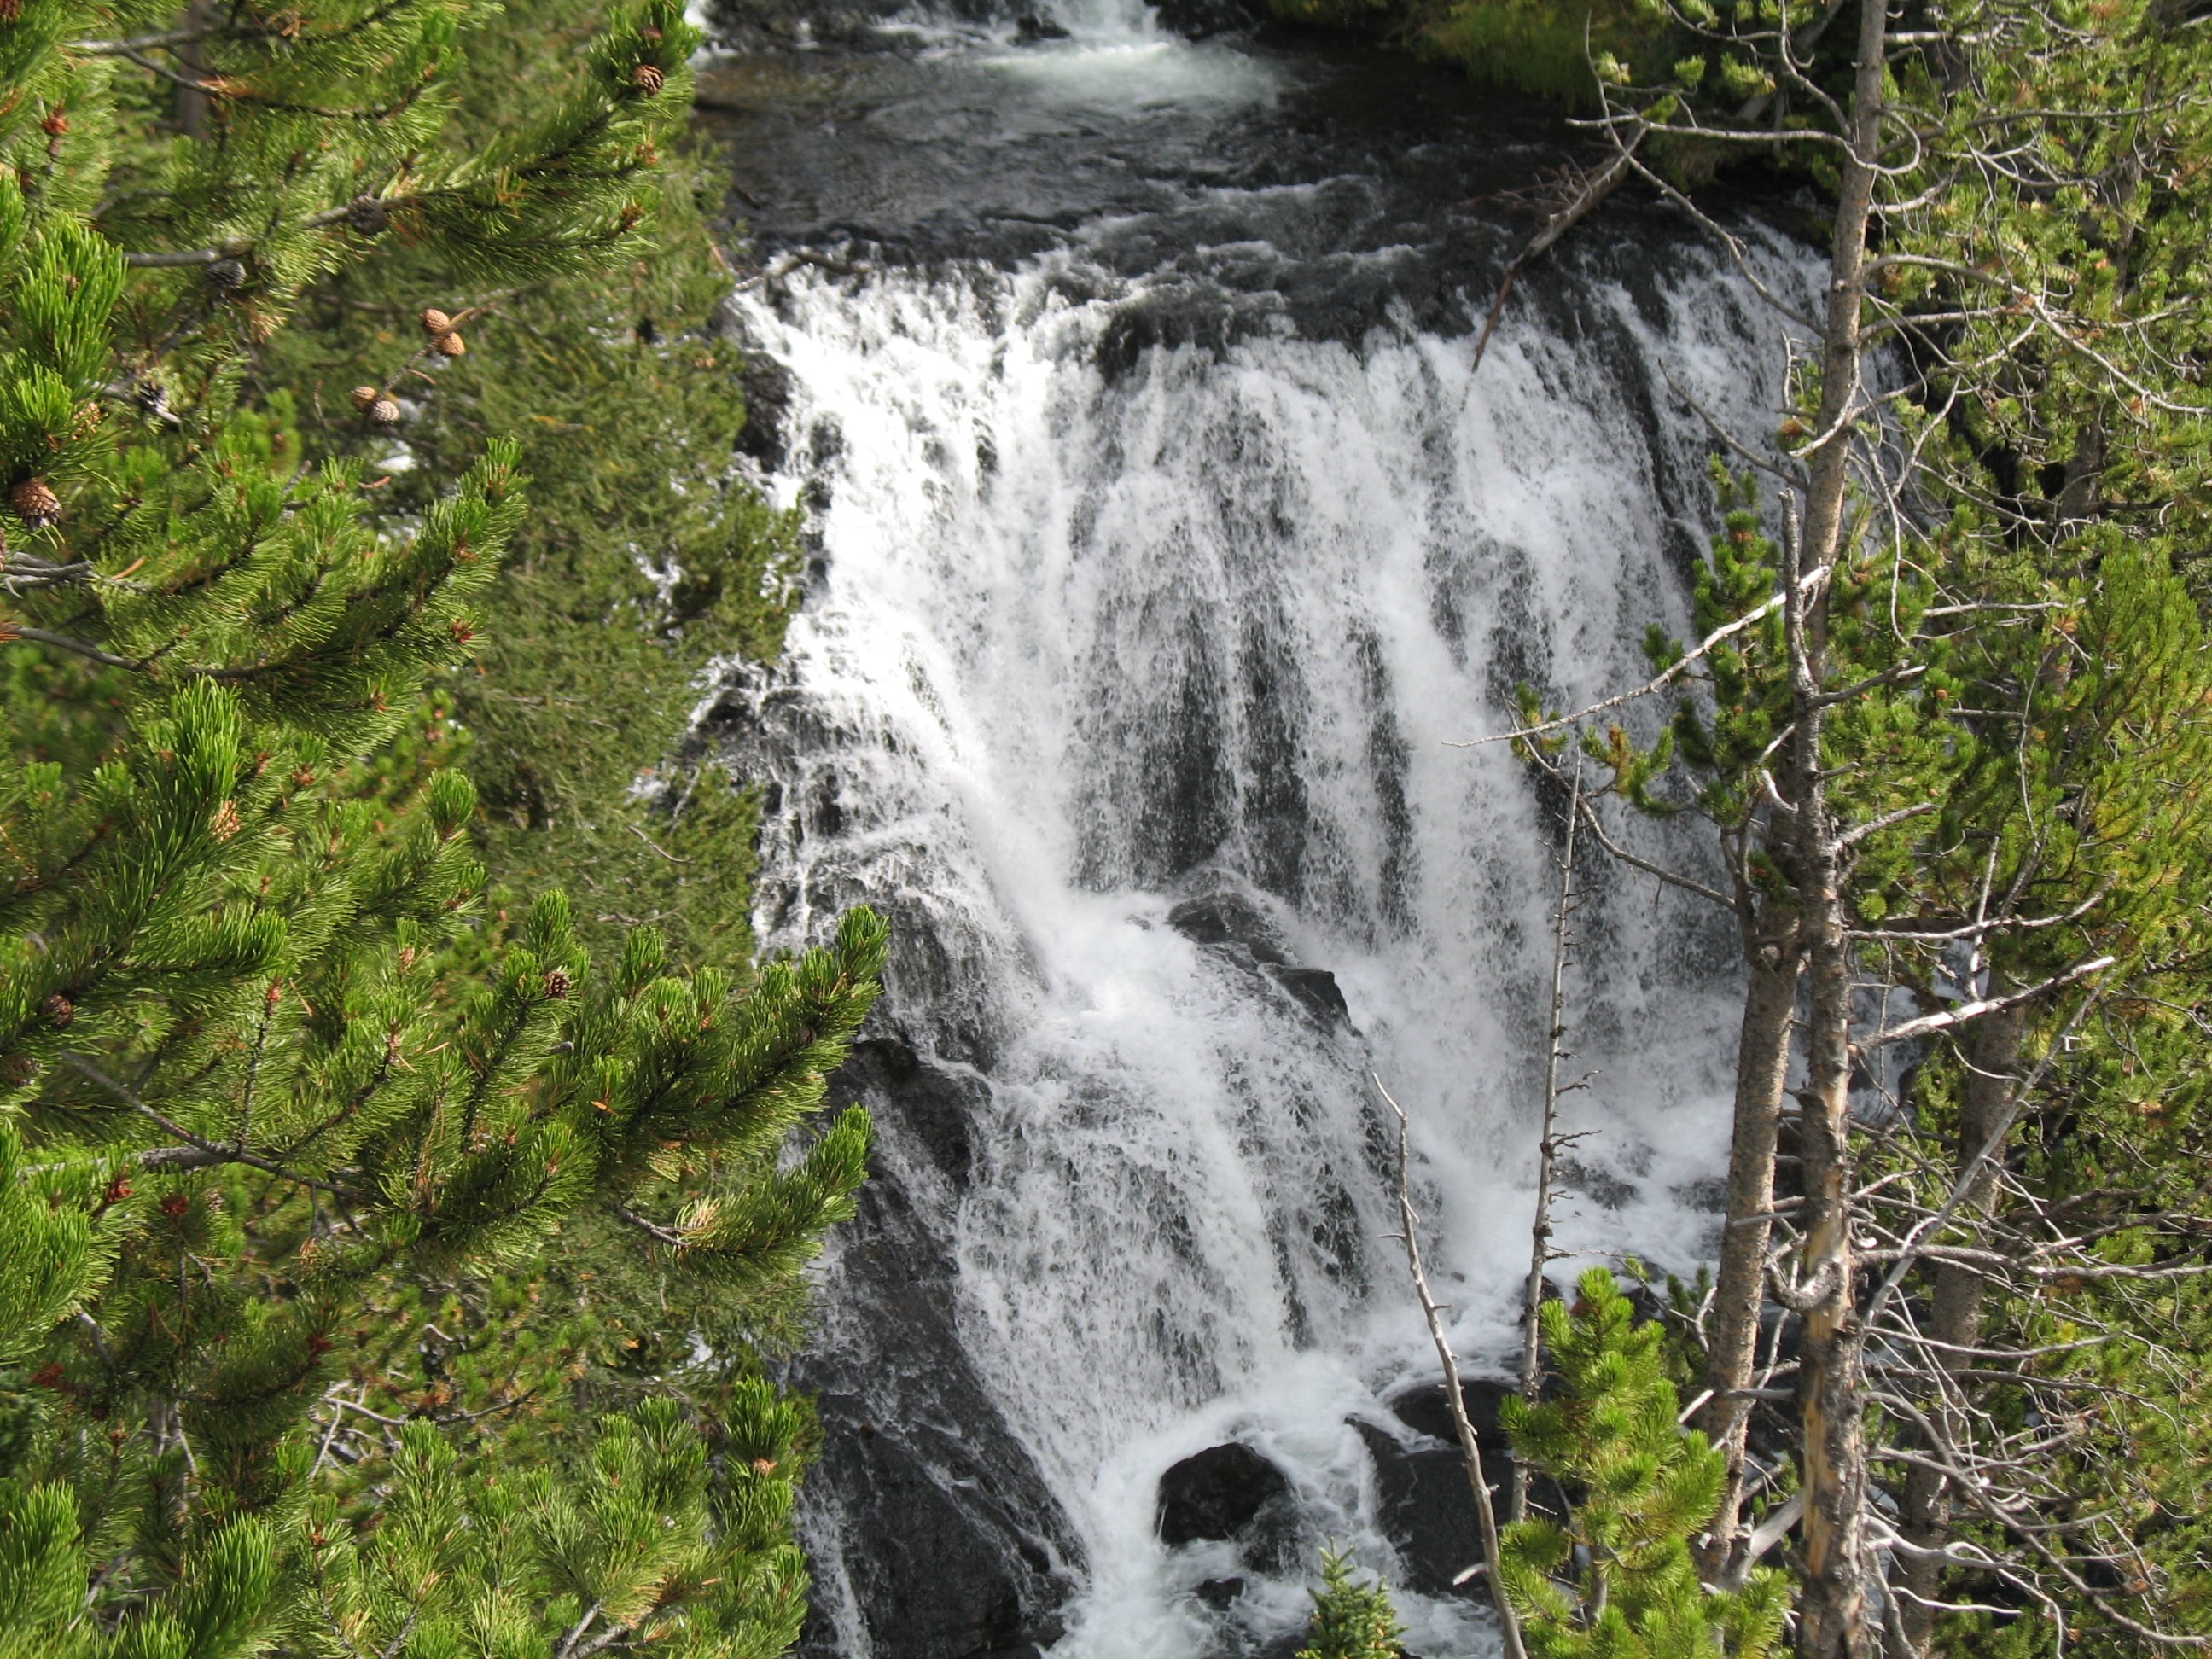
[0, 0, 885, 1659]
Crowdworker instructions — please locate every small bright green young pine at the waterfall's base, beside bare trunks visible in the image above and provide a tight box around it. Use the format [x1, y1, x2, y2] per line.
[1499, 1267, 1790, 1659]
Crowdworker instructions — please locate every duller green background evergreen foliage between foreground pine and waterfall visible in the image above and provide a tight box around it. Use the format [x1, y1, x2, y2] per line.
[257, 0, 800, 969]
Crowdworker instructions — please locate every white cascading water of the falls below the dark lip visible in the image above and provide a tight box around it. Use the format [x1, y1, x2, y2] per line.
[716, 29, 1822, 1659]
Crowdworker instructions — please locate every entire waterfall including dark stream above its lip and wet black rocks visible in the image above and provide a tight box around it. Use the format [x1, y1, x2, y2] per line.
[699, 14, 1809, 1659]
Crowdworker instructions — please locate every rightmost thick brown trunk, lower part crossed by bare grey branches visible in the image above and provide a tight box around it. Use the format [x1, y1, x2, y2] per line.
[1898, 984, 2029, 1655]
